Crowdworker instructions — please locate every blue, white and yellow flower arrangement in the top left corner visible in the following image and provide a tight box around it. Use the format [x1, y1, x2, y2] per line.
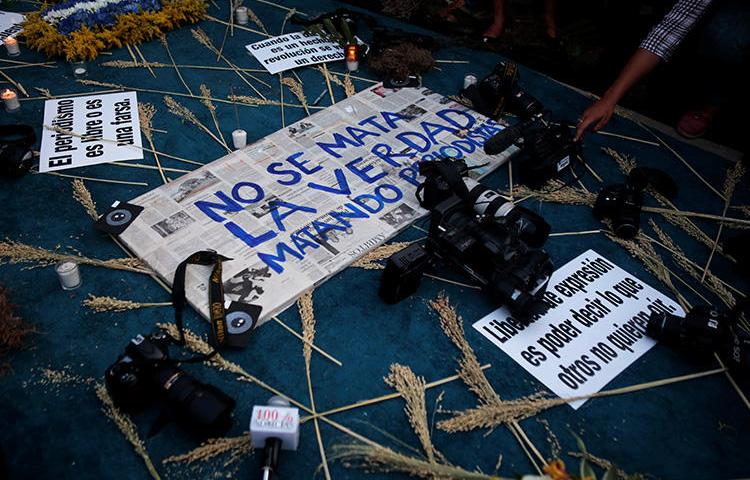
[23, 0, 206, 60]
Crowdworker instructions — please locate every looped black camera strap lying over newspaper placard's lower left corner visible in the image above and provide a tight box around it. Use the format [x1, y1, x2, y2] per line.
[172, 250, 231, 348]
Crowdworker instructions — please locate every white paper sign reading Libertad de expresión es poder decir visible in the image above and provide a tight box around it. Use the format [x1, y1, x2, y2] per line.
[474, 250, 684, 409]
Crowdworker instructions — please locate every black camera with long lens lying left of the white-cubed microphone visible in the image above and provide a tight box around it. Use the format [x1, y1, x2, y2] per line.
[104, 331, 235, 438]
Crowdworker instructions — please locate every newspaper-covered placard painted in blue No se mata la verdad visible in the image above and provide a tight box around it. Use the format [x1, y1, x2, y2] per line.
[120, 86, 511, 322]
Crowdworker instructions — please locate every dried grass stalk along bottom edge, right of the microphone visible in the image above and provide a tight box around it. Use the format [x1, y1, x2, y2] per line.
[331, 444, 507, 480]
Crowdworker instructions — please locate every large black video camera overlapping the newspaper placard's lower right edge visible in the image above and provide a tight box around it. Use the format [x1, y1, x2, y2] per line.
[380, 159, 553, 321]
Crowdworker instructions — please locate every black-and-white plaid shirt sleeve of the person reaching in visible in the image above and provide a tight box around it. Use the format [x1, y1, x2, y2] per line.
[640, 0, 713, 61]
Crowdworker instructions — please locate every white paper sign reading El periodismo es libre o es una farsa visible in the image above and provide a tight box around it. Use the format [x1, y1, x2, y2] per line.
[39, 92, 143, 172]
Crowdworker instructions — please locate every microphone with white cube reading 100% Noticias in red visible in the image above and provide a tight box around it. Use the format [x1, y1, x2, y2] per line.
[250, 396, 299, 480]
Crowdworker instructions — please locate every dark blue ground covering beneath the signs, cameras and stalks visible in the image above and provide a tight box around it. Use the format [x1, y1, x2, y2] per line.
[0, 1, 750, 480]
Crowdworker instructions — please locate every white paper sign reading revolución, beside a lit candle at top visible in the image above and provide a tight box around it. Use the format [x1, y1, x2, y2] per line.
[251, 32, 344, 73]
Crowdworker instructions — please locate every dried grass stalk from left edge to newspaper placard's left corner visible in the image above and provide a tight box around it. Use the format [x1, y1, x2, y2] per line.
[0, 240, 152, 274]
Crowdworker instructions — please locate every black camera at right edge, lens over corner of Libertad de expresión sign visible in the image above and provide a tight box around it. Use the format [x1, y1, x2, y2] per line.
[646, 300, 750, 370]
